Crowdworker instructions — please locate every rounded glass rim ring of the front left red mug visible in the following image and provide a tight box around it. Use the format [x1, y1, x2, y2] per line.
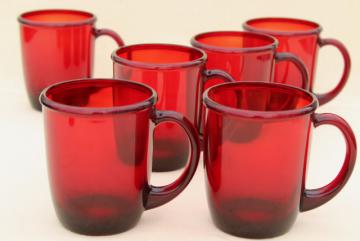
[39, 78, 157, 115]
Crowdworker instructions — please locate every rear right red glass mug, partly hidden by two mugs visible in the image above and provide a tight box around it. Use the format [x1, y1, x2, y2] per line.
[243, 18, 351, 105]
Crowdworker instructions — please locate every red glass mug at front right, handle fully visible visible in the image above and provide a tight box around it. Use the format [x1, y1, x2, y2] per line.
[203, 82, 356, 238]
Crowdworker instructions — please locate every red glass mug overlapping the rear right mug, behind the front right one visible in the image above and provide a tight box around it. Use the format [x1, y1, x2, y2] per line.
[191, 31, 308, 89]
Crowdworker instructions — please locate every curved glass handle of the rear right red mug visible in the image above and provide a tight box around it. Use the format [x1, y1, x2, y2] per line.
[316, 39, 351, 105]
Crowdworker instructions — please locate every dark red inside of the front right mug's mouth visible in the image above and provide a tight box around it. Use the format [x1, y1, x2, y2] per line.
[204, 82, 317, 116]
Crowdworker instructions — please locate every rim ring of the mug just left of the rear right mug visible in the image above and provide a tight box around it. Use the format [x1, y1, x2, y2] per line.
[191, 31, 278, 53]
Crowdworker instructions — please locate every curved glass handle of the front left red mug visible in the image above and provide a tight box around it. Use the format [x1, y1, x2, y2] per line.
[144, 110, 200, 210]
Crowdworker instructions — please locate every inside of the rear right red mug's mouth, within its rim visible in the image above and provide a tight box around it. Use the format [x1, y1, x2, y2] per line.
[245, 18, 319, 32]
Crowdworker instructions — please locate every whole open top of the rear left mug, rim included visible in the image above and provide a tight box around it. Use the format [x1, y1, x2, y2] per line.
[18, 9, 96, 27]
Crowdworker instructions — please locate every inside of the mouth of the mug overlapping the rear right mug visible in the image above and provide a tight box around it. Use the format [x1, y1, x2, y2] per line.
[194, 31, 276, 49]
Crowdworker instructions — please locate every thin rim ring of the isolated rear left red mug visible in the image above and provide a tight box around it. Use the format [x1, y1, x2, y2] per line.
[18, 8, 97, 27]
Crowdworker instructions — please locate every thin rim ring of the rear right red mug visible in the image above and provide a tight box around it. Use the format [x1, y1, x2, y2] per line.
[243, 17, 322, 36]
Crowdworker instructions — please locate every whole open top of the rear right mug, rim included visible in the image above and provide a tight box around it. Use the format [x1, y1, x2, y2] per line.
[243, 17, 322, 36]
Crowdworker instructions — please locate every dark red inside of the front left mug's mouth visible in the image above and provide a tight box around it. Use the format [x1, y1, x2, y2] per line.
[41, 79, 156, 108]
